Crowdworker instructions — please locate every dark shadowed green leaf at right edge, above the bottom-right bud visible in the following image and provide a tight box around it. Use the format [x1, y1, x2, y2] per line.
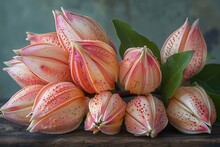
[190, 64, 220, 96]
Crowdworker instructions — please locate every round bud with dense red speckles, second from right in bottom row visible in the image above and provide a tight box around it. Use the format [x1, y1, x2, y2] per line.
[125, 94, 168, 137]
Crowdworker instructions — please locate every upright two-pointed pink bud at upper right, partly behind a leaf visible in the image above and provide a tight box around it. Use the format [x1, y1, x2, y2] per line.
[161, 19, 207, 80]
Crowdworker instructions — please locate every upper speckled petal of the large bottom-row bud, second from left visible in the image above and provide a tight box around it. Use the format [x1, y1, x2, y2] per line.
[31, 82, 84, 120]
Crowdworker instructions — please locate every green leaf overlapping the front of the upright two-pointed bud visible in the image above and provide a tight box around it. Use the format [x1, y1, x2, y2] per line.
[161, 51, 194, 104]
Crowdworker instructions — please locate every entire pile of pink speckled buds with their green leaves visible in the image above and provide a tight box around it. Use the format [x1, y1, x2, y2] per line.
[0, 8, 220, 137]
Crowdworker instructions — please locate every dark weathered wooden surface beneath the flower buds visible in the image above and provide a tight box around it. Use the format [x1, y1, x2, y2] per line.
[0, 104, 220, 147]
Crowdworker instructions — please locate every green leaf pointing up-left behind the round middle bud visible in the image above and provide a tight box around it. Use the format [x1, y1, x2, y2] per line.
[112, 19, 160, 62]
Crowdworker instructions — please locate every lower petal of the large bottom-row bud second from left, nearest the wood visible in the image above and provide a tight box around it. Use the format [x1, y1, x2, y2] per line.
[29, 99, 87, 134]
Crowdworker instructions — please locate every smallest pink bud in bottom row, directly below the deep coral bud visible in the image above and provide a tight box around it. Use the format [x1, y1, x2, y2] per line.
[85, 92, 126, 135]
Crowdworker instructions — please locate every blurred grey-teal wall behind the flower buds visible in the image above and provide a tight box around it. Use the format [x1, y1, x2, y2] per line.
[0, 0, 220, 100]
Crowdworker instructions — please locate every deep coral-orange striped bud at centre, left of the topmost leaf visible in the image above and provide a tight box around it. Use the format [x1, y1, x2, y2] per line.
[70, 40, 119, 93]
